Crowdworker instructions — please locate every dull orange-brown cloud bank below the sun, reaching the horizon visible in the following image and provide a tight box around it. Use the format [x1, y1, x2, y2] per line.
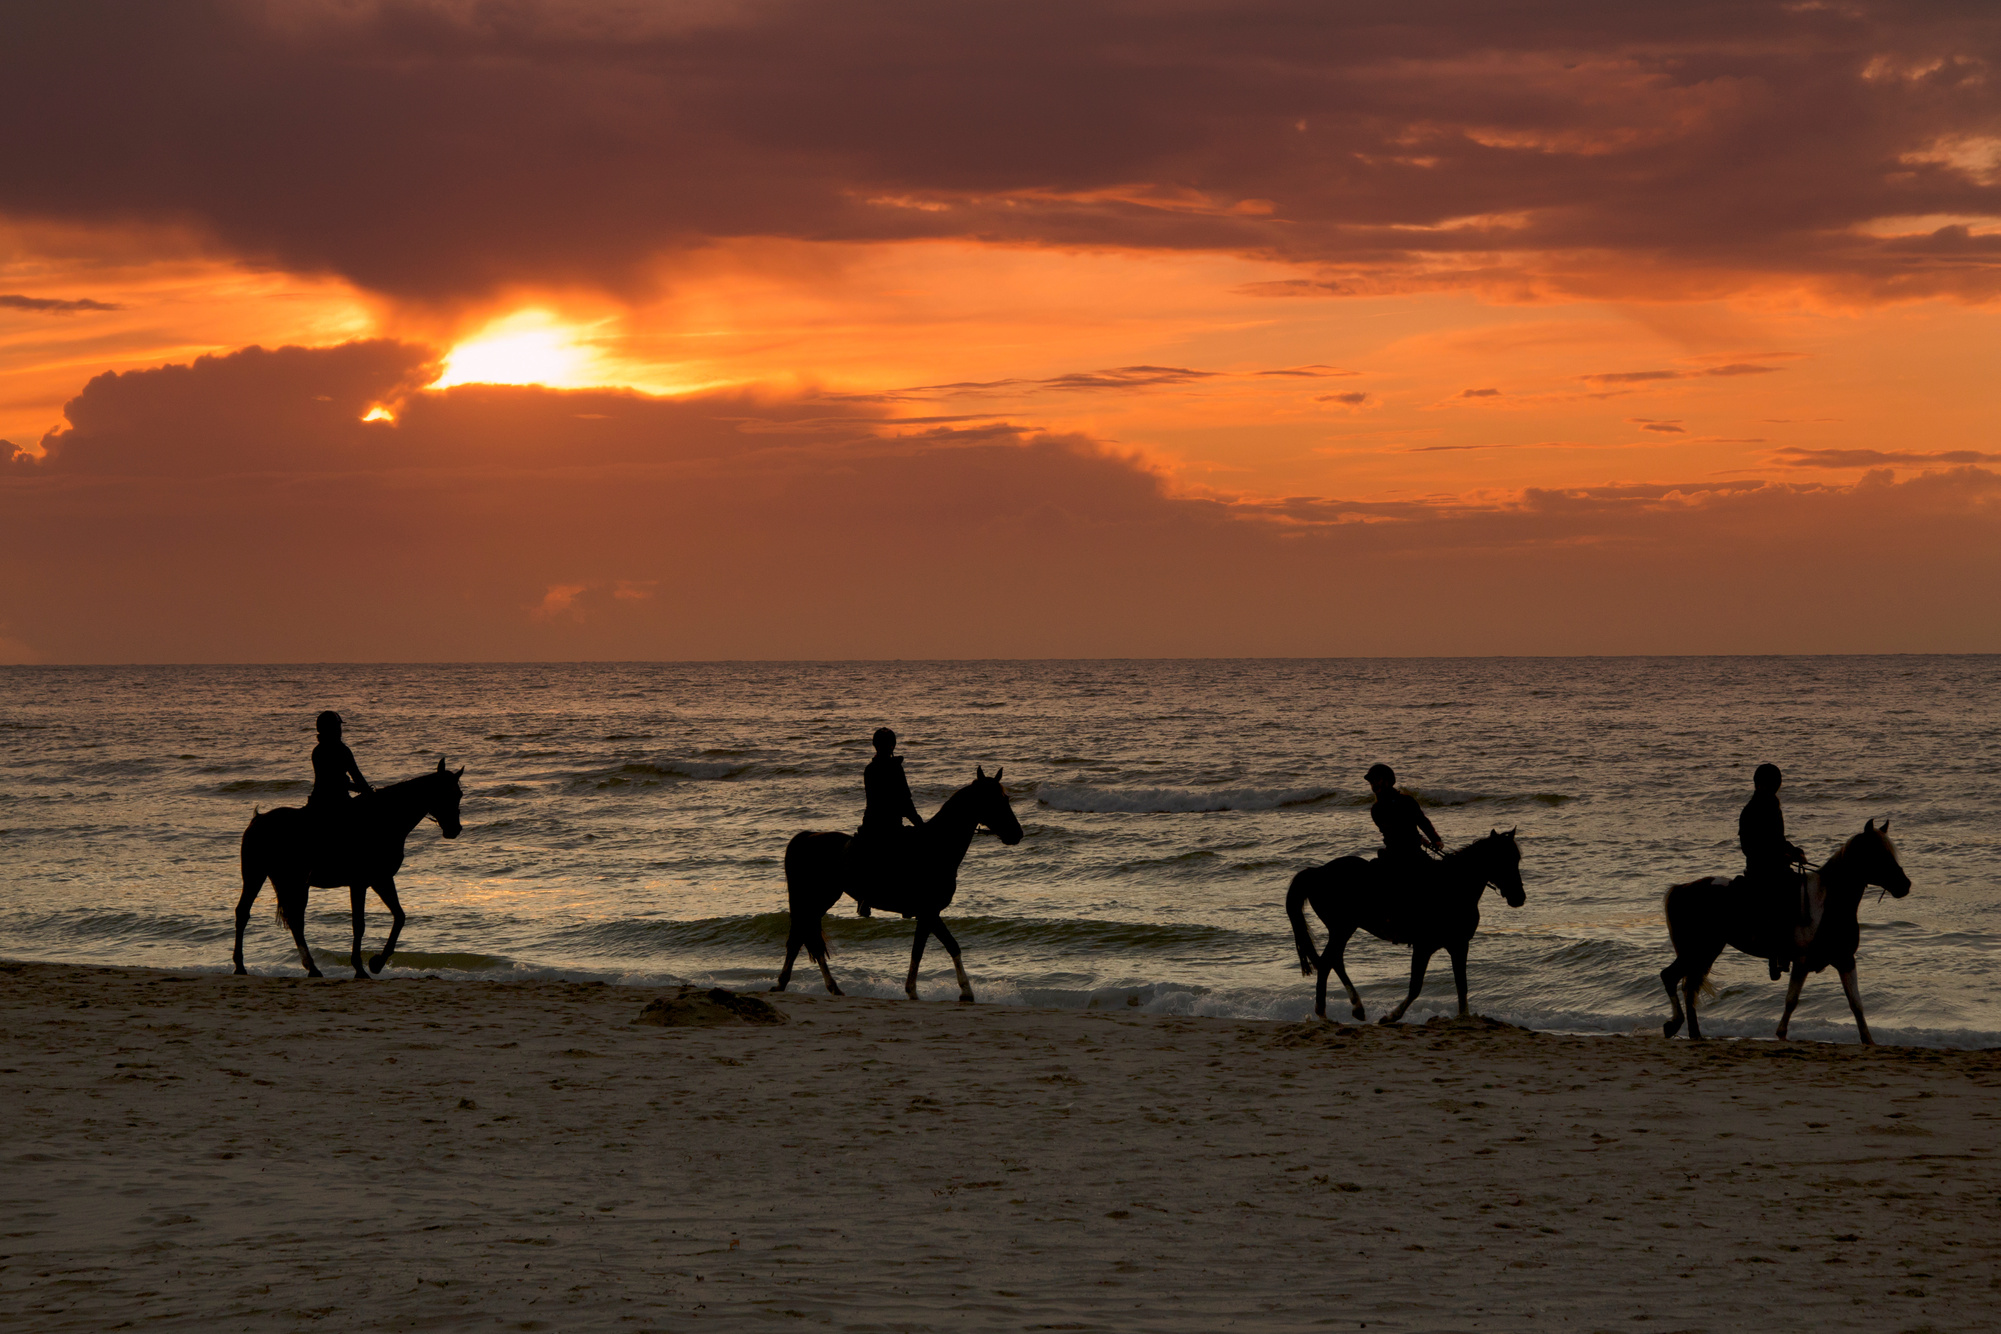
[0, 344, 2001, 660]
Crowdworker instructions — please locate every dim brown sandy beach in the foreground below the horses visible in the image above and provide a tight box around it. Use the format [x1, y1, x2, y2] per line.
[0, 964, 2001, 1332]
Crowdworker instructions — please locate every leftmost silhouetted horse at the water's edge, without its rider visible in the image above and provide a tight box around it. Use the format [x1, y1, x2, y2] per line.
[236, 760, 466, 978]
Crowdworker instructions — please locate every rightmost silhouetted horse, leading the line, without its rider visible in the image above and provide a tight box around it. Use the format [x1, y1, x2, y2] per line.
[1661, 820, 1911, 1044]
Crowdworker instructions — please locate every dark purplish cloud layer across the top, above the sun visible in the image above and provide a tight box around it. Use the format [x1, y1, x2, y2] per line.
[0, 0, 2001, 302]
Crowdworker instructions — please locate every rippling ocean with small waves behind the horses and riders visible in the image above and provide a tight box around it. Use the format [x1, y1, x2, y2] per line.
[0, 656, 2001, 1046]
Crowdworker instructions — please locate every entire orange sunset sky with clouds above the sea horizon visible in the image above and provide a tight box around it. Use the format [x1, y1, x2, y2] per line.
[0, 0, 2001, 662]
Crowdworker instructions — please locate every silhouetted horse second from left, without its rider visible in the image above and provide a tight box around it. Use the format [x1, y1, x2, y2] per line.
[770, 768, 1021, 1002]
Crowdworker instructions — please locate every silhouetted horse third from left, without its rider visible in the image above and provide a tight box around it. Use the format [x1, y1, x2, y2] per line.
[1285, 830, 1529, 1024]
